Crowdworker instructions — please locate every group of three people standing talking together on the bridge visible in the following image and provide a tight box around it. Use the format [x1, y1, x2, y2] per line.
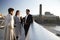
[4, 8, 33, 40]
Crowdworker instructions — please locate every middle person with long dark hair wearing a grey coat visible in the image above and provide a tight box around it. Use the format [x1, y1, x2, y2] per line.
[14, 10, 25, 40]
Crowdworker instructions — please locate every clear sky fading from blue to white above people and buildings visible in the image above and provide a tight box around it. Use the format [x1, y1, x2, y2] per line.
[0, 0, 60, 16]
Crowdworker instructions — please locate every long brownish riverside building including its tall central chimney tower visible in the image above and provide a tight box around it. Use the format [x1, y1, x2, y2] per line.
[33, 4, 60, 24]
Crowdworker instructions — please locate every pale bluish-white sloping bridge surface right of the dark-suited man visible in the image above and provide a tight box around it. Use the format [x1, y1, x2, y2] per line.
[26, 22, 60, 40]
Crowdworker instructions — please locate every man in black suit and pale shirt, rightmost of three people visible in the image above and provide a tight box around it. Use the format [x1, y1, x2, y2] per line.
[24, 9, 33, 37]
